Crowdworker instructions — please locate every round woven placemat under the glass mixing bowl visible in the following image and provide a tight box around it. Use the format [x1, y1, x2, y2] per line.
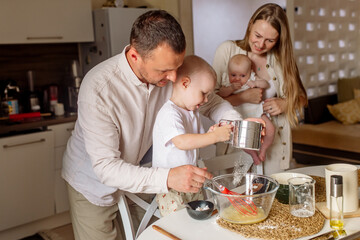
[216, 199, 325, 240]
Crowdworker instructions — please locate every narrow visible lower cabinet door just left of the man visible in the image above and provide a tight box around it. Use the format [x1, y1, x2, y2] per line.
[48, 122, 75, 213]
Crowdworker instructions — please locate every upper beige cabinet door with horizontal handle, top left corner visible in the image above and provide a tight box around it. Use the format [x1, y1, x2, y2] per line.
[0, 0, 94, 44]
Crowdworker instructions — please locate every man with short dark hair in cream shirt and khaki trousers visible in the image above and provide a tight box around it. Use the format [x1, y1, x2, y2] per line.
[62, 10, 240, 240]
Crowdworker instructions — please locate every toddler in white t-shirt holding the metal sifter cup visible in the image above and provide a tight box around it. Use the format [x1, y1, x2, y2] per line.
[152, 56, 231, 216]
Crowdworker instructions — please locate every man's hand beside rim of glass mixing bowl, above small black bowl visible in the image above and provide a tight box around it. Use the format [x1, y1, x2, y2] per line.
[167, 165, 213, 193]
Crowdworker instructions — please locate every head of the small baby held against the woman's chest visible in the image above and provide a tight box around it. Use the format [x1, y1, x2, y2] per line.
[228, 54, 251, 85]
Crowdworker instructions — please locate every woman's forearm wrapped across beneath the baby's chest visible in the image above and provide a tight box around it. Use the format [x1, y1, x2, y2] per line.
[224, 88, 264, 106]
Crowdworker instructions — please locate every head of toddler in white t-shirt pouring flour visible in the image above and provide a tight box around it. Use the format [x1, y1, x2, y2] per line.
[172, 55, 216, 111]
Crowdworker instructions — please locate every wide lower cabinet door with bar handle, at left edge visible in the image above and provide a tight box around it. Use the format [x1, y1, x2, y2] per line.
[0, 131, 55, 230]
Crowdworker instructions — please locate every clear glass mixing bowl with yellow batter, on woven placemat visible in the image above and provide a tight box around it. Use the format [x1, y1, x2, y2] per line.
[204, 173, 279, 224]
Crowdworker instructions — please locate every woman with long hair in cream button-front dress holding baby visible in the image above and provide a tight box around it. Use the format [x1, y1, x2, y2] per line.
[213, 3, 307, 175]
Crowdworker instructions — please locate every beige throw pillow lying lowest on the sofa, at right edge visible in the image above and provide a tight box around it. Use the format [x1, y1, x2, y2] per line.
[327, 98, 360, 124]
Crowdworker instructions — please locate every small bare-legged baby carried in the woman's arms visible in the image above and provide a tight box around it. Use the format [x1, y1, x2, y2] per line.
[217, 54, 275, 164]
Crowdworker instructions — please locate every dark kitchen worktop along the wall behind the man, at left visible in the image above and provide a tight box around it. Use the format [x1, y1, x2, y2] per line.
[0, 114, 77, 137]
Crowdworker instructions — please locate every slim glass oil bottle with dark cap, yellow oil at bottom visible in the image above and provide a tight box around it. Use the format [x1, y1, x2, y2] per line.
[330, 175, 344, 230]
